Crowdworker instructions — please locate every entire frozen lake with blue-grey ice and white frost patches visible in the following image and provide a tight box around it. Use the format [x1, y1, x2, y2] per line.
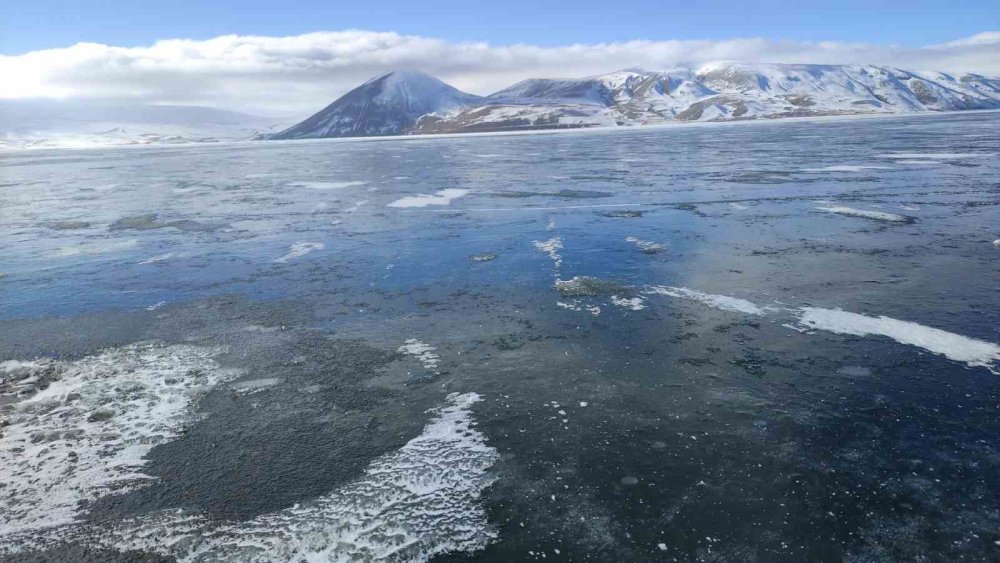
[0, 113, 1000, 561]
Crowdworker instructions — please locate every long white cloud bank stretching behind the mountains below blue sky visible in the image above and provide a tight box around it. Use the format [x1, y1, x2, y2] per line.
[0, 31, 1000, 115]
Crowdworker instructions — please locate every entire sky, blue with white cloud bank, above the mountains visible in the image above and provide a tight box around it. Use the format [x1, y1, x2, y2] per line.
[0, 0, 1000, 115]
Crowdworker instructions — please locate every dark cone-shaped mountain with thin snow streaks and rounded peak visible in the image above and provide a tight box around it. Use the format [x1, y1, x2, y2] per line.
[269, 70, 481, 139]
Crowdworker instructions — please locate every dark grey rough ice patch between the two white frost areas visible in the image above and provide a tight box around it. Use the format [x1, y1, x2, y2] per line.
[90, 333, 439, 520]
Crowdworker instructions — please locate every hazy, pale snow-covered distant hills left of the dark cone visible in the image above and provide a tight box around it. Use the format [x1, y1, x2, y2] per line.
[0, 100, 293, 148]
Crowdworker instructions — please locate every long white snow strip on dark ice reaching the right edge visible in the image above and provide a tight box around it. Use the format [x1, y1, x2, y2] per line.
[799, 307, 1000, 374]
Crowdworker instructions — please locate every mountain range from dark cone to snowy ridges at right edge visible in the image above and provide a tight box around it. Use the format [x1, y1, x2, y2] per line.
[269, 63, 1000, 139]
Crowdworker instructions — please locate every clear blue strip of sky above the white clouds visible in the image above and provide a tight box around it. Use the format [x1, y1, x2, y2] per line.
[0, 0, 1000, 55]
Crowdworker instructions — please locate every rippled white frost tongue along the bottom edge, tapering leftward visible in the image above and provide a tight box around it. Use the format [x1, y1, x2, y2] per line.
[0, 393, 499, 562]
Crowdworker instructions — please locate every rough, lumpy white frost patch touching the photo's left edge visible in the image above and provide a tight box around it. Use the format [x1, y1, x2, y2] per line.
[0, 344, 238, 538]
